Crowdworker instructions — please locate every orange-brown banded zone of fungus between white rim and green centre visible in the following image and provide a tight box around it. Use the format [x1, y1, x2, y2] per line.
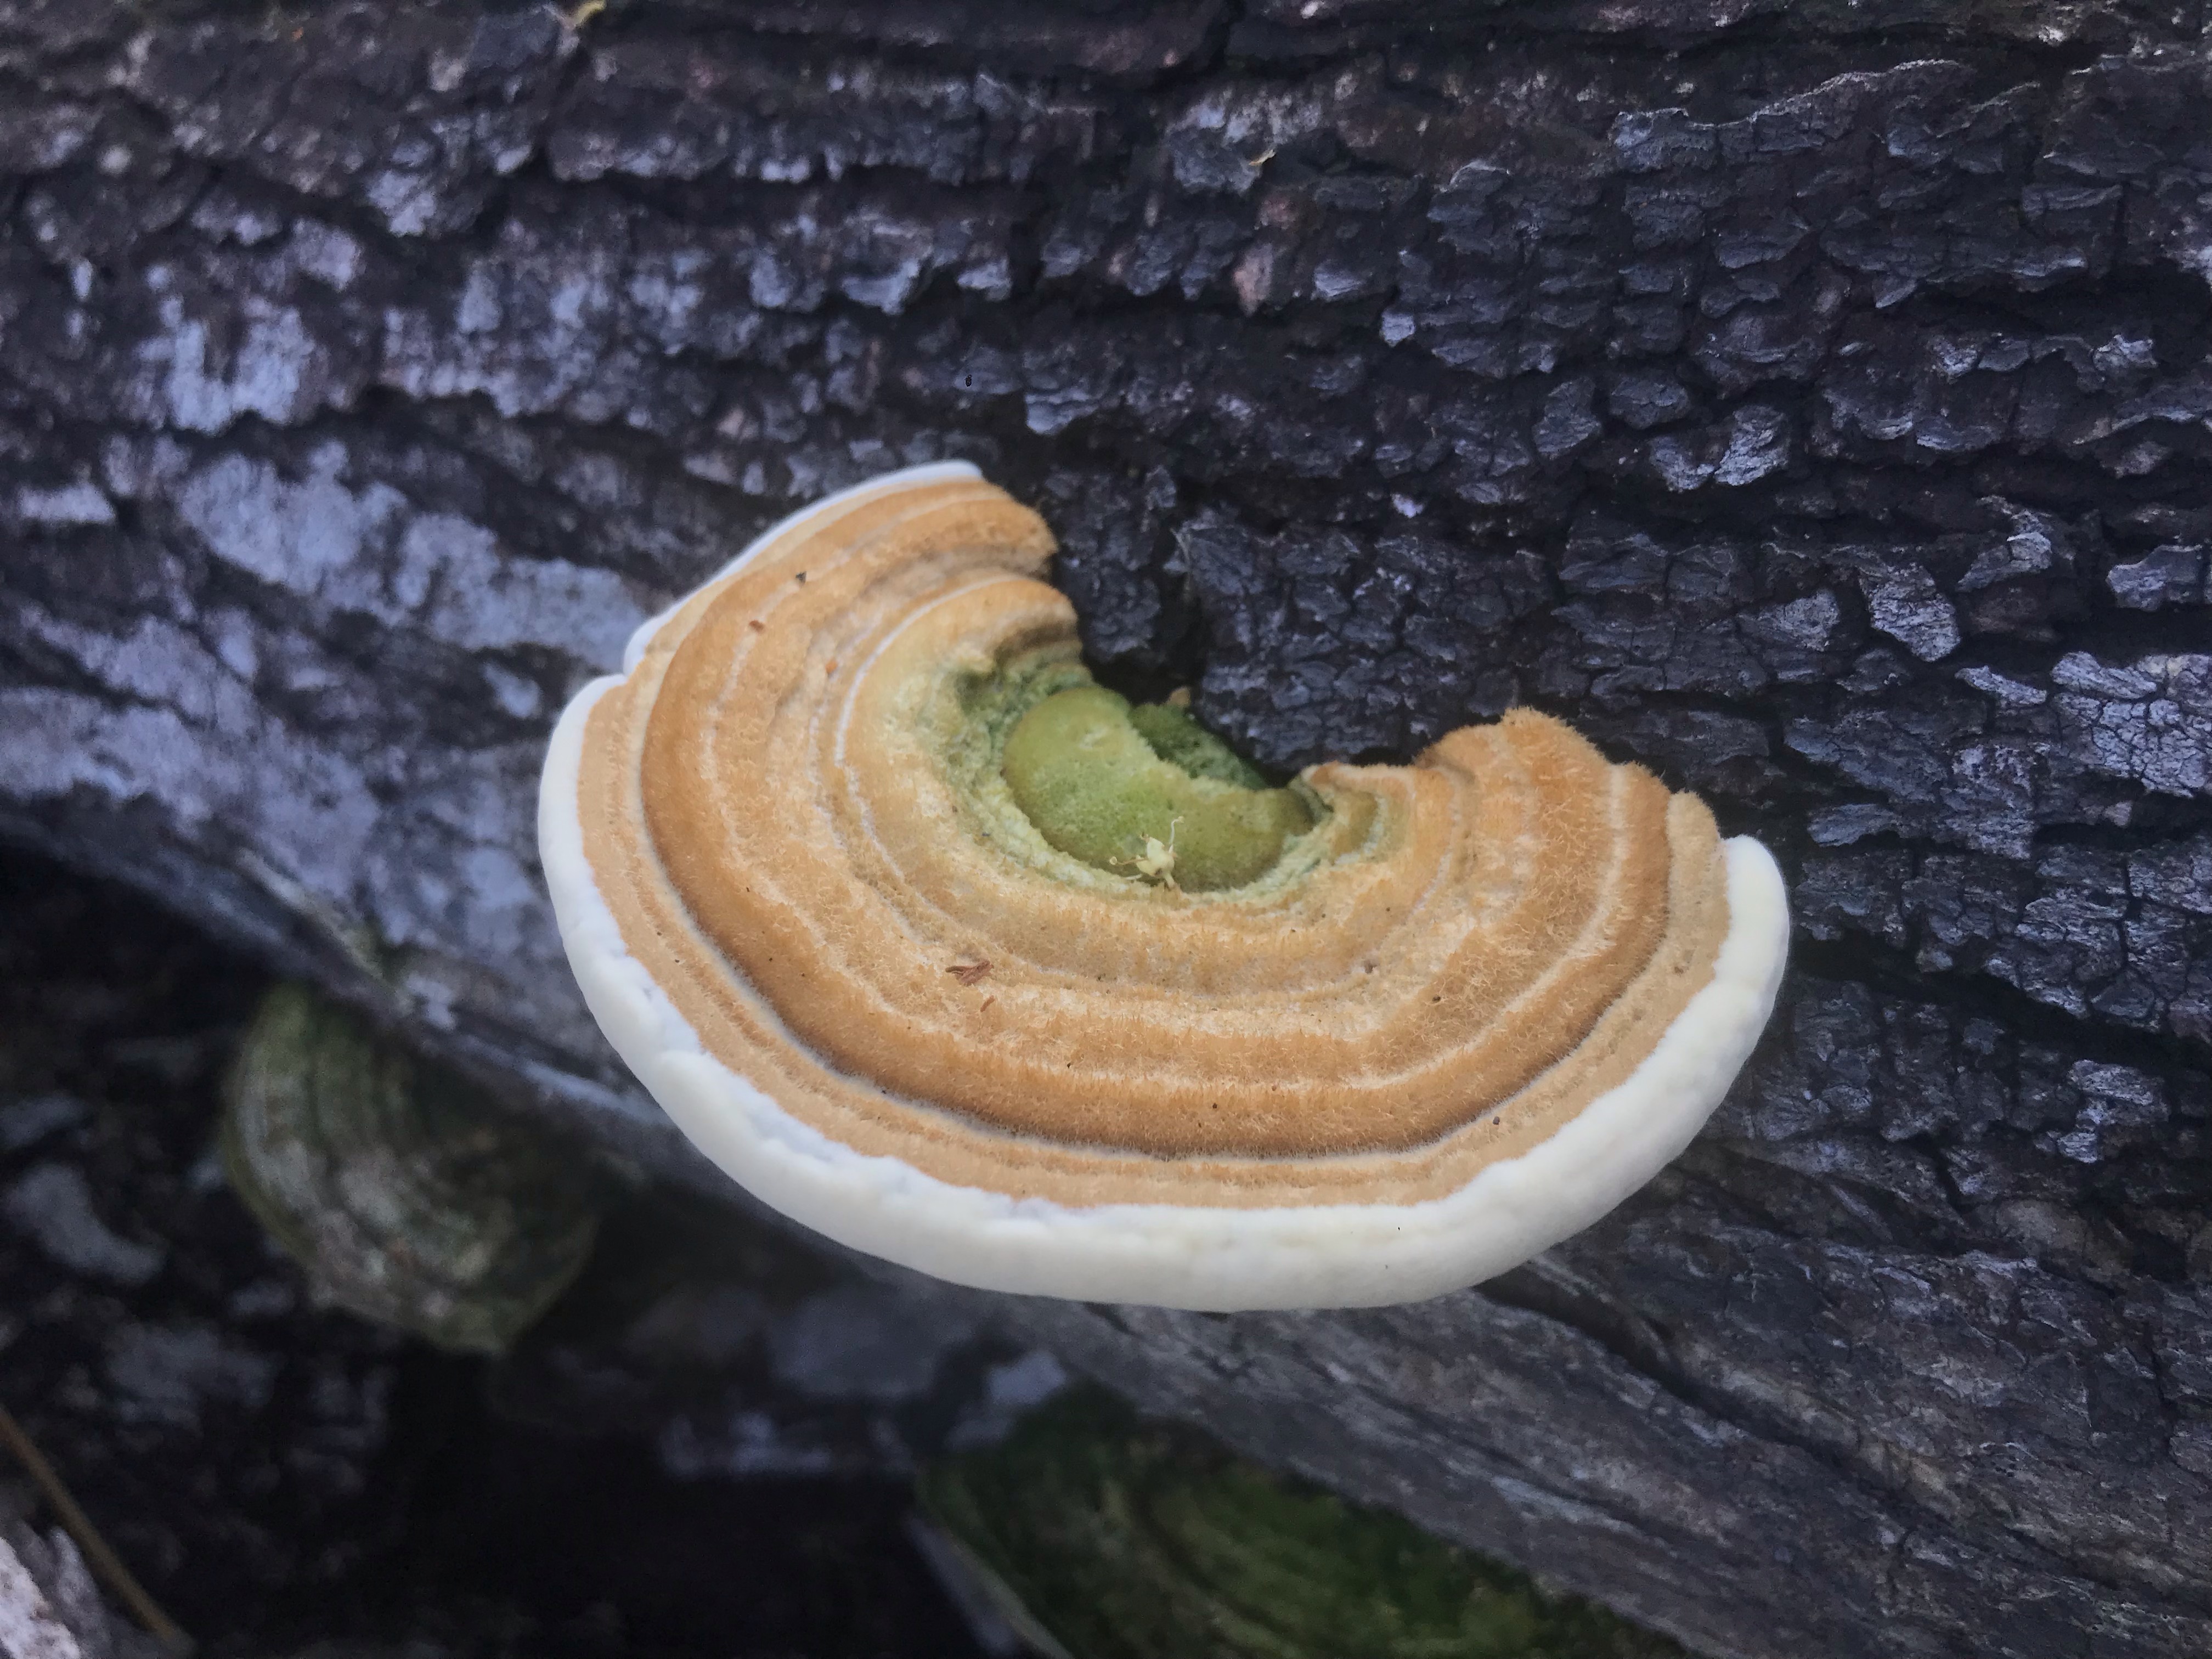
[582, 482, 1728, 1205]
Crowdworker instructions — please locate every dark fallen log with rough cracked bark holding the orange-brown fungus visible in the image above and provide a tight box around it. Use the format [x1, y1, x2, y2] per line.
[0, 0, 2212, 1659]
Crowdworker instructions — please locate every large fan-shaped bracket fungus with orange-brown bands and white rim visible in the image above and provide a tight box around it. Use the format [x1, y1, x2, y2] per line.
[540, 465, 1787, 1310]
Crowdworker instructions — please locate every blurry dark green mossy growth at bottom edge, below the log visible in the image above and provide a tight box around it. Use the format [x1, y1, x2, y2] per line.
[920, 1391, 1683, 1659]
